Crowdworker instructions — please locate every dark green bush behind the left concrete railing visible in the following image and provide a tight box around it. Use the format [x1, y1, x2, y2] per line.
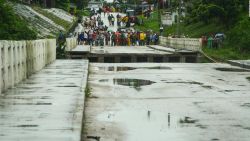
[0, 0, 37, 40]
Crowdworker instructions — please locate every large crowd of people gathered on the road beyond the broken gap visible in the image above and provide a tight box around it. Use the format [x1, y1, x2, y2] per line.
[78, 13, 159, 46]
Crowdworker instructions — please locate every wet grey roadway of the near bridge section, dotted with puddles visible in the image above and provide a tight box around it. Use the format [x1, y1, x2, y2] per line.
[83, 63, 250, 141]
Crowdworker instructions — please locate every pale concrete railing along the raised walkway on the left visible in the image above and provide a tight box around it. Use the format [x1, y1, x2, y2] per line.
[0, 39, 56, 93]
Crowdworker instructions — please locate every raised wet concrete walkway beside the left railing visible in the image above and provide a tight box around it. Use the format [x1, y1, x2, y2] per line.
[0, 60, 88, 141]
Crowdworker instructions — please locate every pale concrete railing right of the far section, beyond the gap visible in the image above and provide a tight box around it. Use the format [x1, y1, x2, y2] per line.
[160, 36, 202, 51]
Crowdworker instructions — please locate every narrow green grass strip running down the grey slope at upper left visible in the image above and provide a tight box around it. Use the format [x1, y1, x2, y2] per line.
[32, 6, 72, 31]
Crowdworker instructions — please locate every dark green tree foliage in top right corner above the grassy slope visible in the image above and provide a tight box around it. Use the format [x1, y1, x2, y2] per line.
[184, 0, 248, 27]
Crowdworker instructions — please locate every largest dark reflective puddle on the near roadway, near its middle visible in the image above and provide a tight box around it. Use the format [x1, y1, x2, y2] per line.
[113, 78, 155, 88]
